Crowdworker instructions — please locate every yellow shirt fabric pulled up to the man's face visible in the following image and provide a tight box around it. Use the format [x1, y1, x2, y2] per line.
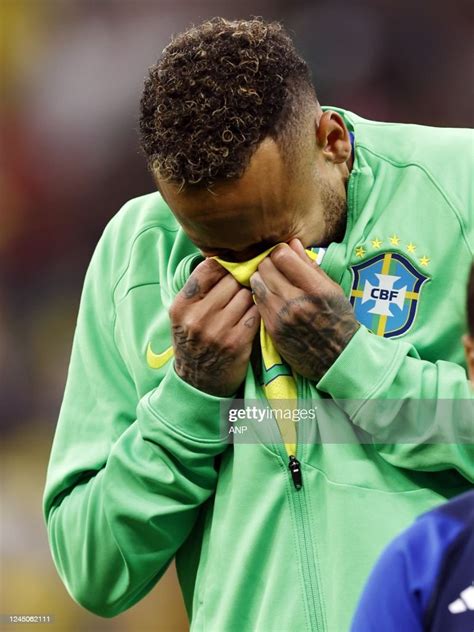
[213, 244, 317, 456]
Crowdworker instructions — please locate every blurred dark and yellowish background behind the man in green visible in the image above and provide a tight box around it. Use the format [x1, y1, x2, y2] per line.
[0, 0, 474, 632]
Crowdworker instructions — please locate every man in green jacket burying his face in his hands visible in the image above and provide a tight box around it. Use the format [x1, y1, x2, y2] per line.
[44, 19, 474, 632]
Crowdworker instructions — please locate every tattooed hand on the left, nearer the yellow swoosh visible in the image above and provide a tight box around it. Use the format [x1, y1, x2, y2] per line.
[169, 259, 260, 397]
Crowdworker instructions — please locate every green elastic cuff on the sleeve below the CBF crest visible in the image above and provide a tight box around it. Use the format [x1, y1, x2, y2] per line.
[316, 325, 406, 412]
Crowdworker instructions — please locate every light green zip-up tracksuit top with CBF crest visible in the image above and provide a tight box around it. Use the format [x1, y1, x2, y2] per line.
[43, 110, 474, 632]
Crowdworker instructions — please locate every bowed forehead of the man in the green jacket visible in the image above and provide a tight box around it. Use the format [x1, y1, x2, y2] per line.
[159, 139, 291, 248]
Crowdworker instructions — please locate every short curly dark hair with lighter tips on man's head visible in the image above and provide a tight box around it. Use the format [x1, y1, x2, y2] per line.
[140, 18, 317, 188]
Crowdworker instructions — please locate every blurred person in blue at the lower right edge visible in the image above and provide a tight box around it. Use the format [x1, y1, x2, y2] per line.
[351, 264, 474, 632]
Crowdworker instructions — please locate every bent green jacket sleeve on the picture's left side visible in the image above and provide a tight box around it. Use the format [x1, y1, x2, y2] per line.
[43, 226, 227, 617]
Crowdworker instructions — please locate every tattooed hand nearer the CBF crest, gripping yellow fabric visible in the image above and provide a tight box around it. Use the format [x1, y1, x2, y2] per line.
[250, 239, 359, 381]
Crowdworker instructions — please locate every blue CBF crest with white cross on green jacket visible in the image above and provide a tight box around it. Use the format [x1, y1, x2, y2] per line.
[350, 252, 429, 338]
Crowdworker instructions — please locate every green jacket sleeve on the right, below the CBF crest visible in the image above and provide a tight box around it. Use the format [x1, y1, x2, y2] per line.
[316, 325, 474, 481]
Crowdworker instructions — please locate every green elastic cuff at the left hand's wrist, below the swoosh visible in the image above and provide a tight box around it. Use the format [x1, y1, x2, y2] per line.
[144, 364, 232, 442]
